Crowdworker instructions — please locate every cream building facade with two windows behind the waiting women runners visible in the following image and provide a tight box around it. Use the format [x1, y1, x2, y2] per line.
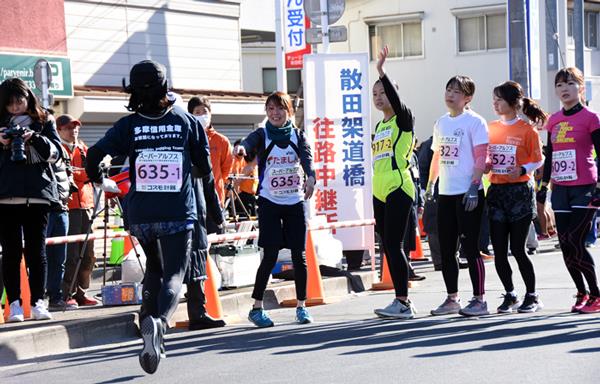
[243, 0, 600, 140]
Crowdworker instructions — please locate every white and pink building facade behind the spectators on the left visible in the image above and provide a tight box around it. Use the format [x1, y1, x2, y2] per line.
[0, 0, 264, 144]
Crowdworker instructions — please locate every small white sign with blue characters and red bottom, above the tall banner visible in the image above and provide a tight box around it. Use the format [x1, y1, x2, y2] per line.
[282, 0, 311, 69]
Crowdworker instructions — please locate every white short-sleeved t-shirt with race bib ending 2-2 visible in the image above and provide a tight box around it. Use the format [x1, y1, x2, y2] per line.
[431, 109, 489, 195]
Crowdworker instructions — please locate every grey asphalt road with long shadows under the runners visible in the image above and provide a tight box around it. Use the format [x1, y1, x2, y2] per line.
[0, 242, 600, 384]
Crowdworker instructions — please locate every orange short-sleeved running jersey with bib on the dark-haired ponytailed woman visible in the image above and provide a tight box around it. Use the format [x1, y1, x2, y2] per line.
[488, 120, 543, 184]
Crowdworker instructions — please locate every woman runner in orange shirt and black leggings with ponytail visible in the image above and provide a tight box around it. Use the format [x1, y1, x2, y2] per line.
[486, 81, 547, 313]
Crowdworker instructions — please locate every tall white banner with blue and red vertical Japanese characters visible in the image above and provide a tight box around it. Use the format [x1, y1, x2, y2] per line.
[304, 53, 374, 250]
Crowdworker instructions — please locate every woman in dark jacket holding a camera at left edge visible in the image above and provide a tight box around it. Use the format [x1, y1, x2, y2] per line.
[0, 78, 60, 322]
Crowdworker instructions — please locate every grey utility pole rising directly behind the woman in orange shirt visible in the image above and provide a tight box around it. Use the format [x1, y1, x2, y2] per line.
[508, 0, 529, 95]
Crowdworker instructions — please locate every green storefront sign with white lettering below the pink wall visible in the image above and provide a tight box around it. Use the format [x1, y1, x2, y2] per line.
[0, 54, 73, 97]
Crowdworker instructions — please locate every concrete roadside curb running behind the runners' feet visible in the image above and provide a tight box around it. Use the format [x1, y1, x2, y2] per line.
[0, 271, 377, 365]
